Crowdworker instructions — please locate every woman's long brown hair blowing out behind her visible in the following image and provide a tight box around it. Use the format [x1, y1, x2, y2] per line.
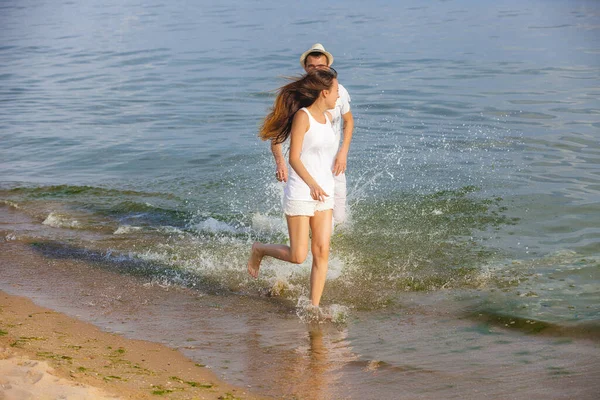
[258, 68, 337, 143]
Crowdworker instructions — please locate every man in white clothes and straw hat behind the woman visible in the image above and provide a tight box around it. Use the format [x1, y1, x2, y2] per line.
[271, 43, 354, 224]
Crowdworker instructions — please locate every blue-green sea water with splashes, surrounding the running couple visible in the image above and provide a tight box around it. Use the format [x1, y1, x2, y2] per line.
[0, 0, 600, 399]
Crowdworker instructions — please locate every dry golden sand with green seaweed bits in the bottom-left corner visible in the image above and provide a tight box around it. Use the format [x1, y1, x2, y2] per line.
[0, 291, 264, 400]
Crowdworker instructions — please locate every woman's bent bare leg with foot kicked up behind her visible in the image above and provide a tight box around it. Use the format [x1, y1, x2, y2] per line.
[248, 215, 311, 278]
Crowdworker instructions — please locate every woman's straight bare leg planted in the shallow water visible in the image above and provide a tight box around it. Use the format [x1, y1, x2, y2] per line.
[310, 210, 333, 306]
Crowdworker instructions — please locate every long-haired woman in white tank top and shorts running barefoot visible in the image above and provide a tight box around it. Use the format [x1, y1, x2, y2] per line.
[248, 69, 339, 306]
